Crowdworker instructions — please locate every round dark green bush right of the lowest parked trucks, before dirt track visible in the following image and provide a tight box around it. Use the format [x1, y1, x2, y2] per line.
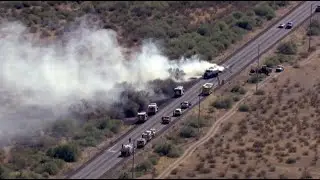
[155, 142, 181, 158]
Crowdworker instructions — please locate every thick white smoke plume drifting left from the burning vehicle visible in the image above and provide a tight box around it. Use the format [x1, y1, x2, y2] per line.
[0, 22, 222, 141]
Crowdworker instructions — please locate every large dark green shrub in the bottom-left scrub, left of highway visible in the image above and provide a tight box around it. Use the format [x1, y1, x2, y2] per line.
[47, 144, 80, 162]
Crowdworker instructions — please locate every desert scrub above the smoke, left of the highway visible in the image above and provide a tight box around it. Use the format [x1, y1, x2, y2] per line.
[0, 1, 289, 60]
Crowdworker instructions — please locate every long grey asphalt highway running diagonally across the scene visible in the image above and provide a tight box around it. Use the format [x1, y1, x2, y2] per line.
[70, 1, 320, 179]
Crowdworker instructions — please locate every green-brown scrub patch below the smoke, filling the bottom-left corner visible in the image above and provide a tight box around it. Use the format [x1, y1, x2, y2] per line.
[0, 118, 123, 179]
